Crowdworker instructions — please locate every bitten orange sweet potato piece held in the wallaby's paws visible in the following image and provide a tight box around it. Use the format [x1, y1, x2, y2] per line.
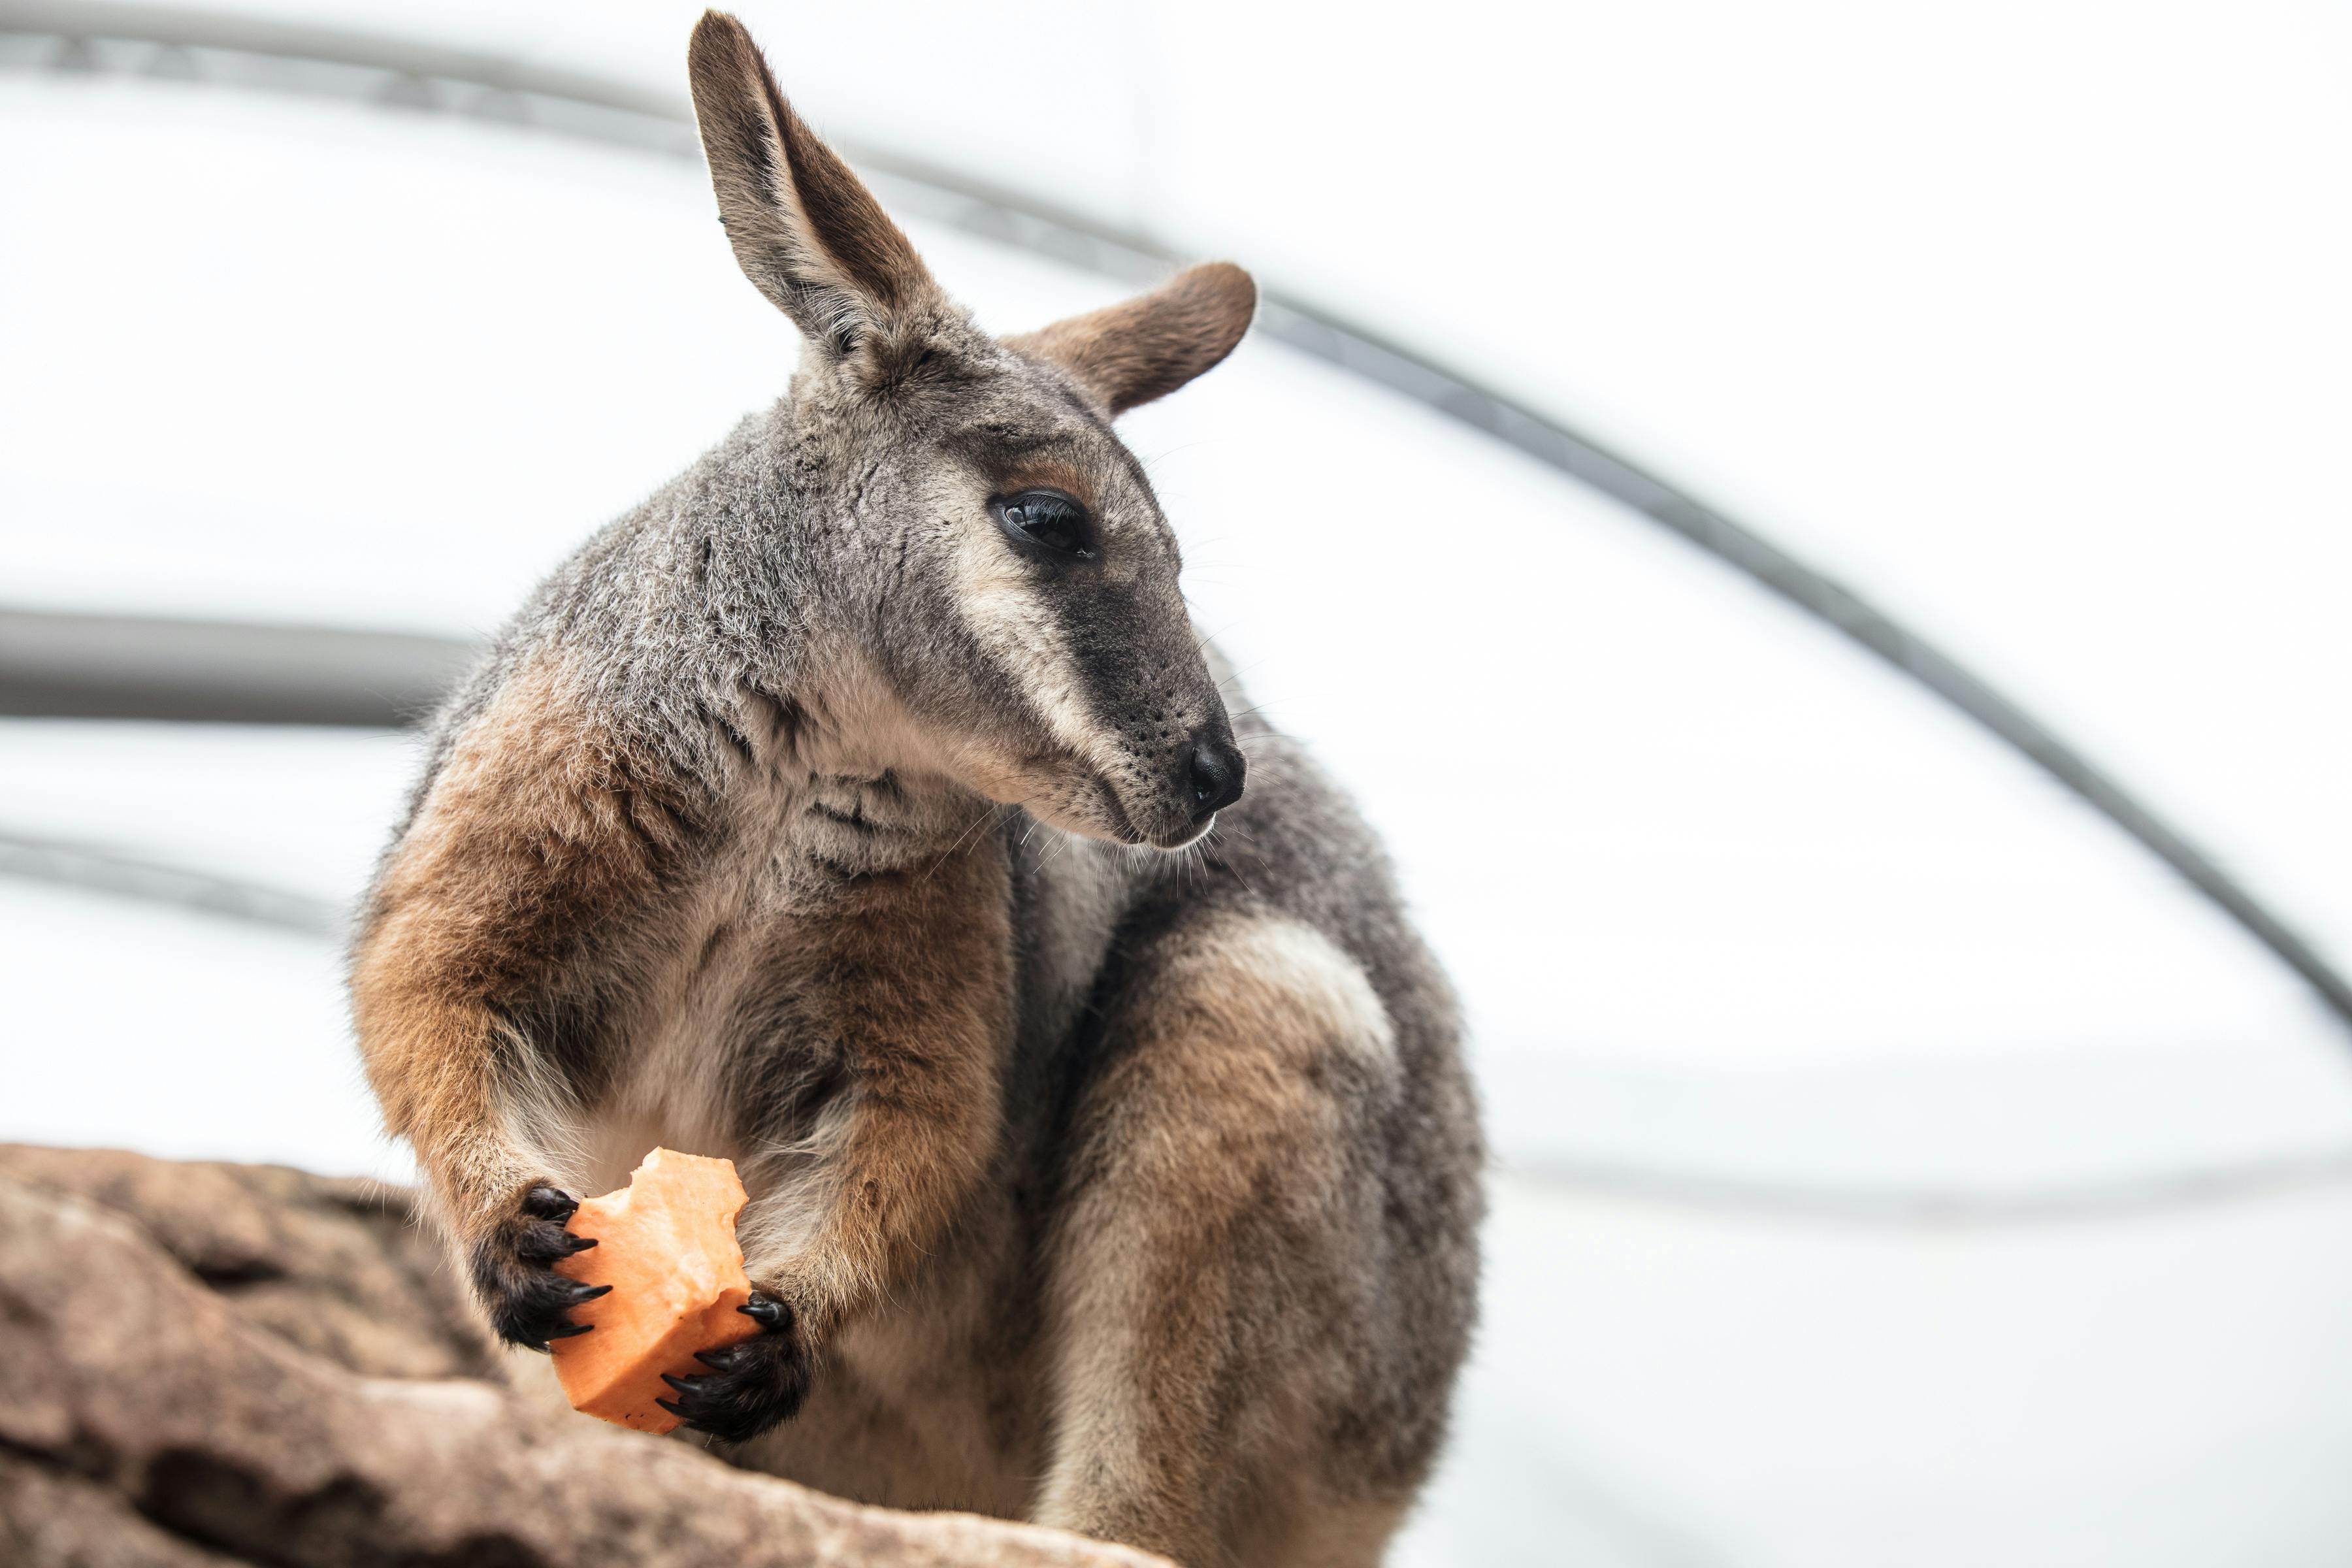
[553, 1150, 760, 1431]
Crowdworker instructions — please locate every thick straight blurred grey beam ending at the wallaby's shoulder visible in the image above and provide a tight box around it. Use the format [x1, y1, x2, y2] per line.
[0, 609, 475, 728]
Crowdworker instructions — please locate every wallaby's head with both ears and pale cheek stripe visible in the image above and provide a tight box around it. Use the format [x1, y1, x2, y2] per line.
[689, 12, 1256, 849]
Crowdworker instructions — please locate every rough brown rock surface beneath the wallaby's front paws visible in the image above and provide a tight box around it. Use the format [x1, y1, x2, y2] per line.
[0, 1145, 1157, 1568]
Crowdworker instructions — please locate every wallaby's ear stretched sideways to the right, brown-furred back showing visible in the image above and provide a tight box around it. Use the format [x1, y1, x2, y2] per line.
[1004, 261, 1258, 416]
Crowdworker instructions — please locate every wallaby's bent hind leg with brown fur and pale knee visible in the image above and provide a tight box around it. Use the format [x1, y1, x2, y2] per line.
[1037, 912, 1444, 1568]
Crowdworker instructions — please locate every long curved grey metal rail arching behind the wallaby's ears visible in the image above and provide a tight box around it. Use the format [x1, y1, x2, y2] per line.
[0, 0, 2352, 1025]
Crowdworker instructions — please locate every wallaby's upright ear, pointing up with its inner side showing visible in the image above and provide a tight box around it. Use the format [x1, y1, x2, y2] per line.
[687, 12, 938, 355]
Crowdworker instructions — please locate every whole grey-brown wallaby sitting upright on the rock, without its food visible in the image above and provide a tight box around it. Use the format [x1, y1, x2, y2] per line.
[350, 14, 1479, 1563]
